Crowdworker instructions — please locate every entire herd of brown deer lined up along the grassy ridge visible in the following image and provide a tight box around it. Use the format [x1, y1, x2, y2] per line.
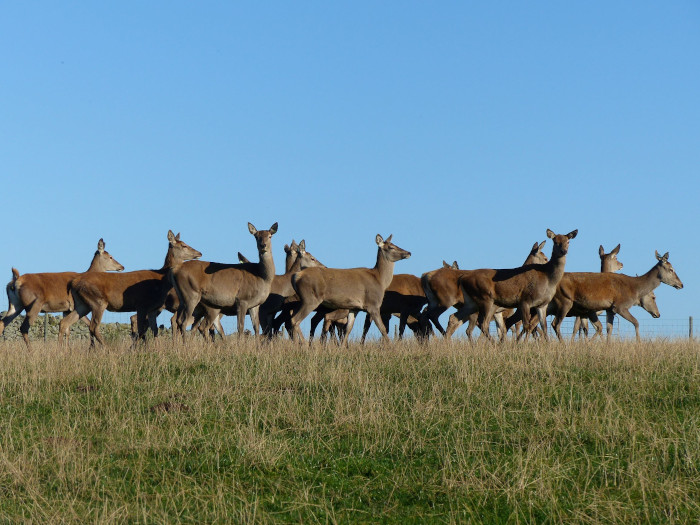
[0, 223, 683, 348]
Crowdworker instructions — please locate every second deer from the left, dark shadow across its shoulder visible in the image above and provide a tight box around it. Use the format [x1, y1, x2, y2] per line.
[59, 231, 202, 345]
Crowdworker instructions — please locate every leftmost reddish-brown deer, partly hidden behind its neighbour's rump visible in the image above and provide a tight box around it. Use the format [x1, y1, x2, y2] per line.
[0, 239, 124, 348]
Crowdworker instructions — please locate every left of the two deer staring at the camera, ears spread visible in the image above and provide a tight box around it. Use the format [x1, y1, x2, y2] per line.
[172, 223, 277, 337]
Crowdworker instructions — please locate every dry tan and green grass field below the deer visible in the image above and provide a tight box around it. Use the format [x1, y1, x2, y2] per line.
[0, 339, 700, 523]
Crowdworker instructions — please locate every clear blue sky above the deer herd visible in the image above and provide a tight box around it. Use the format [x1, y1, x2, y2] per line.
[0, 1, 700, 332]
